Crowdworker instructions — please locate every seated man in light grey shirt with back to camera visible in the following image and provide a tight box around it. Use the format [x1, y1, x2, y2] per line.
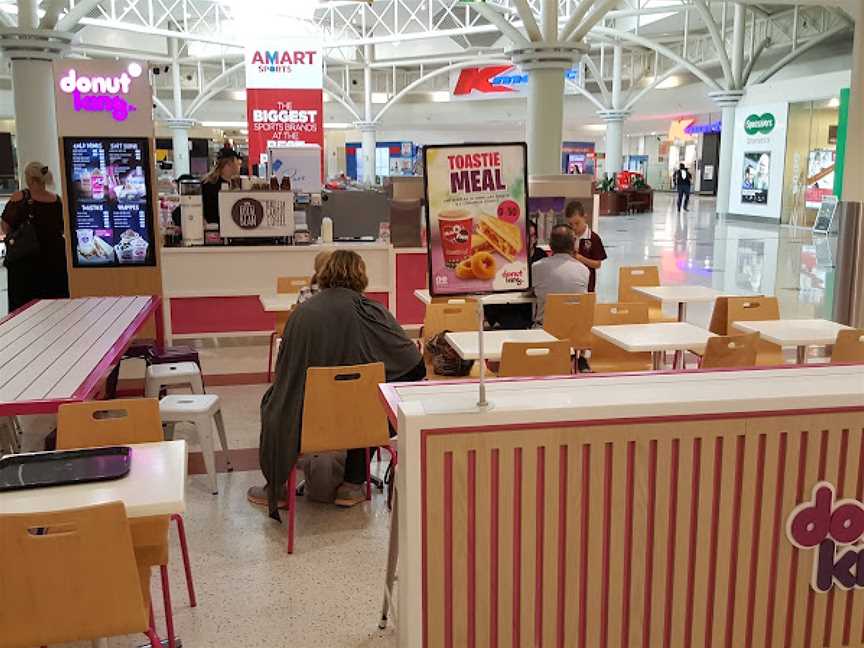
[531, 225, 589, 324]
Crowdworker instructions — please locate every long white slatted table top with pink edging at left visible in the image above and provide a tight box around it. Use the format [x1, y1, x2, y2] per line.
[0, 297, 158, 411]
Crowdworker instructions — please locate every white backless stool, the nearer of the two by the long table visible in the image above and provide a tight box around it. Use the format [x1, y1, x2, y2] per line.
[159, 392, 234, 495]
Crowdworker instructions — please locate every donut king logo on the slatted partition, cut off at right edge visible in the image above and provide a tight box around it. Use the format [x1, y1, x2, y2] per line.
[786, 482, 864, 593]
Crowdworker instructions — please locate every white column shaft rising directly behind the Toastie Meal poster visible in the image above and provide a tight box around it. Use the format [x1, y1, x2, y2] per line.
[527, 67, 564, 175]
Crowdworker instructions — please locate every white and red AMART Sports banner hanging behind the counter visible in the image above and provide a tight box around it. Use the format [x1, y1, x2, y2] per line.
[246, 36, 324, 172]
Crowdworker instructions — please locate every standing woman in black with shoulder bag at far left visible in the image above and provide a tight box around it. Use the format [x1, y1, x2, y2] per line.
[0, 162, 69, 313]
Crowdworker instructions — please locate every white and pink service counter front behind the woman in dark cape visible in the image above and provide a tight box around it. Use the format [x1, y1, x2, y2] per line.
[161, 242, 426, 343]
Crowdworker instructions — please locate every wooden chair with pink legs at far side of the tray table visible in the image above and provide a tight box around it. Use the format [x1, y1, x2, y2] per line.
[57, 398, 198, 645]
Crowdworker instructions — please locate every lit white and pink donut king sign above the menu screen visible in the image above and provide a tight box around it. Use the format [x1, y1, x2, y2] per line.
[57, 63, 144, 122]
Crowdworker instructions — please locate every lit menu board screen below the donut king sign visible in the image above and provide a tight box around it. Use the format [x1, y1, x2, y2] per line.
[63, 137, 156, 268]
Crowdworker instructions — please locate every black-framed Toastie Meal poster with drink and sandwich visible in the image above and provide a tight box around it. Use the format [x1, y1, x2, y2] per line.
[423, 143, 531, 295]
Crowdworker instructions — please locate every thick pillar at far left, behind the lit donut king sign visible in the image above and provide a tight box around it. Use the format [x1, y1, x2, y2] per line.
[0, 29, 72, 192]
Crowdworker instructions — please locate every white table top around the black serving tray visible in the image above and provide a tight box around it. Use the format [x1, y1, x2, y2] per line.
[0, 441, 186, 518]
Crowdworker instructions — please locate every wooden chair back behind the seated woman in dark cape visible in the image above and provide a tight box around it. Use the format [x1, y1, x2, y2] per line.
[300, 362, 390, 454]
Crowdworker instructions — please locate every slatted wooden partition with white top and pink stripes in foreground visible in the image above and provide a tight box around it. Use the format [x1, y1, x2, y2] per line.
[382, 365, 864, 648]
